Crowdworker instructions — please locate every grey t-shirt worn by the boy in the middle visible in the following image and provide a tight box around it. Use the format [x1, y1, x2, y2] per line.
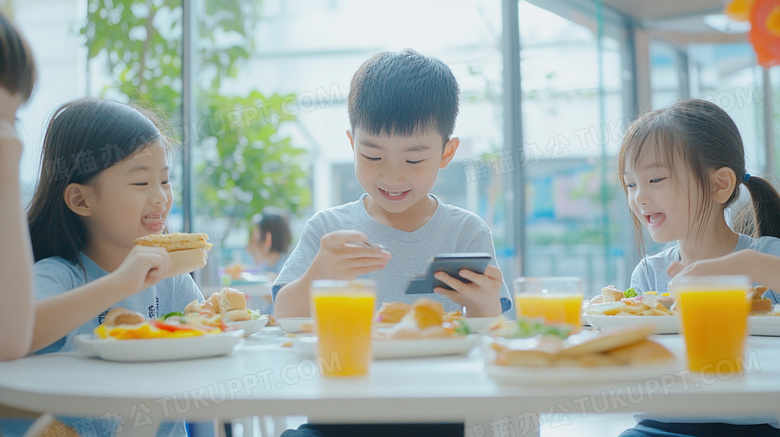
[273, 194, 512, 312]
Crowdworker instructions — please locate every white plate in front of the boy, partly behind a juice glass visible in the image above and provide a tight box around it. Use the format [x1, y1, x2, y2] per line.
[292, 335, 479, 360]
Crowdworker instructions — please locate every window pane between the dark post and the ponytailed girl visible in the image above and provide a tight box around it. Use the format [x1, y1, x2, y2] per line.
[520, 2, 634, 295]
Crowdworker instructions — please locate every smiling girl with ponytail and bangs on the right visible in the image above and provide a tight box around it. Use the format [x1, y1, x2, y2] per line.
[618, 99, 780, 437]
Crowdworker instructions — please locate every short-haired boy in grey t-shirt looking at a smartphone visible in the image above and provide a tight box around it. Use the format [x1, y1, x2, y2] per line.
[273, 49, 511, 319]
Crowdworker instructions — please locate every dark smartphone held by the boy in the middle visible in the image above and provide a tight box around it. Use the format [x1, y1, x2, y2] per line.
[405, 253, 491, 294]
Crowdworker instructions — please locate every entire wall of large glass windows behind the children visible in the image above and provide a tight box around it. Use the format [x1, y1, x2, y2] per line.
[9, 0, 780, 294]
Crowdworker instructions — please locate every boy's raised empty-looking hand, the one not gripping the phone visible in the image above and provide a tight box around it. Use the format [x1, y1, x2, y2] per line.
[309, 231, 391, 279]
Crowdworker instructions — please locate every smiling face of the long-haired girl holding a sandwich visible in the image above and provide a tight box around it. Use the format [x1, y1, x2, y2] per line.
[85, 140, 173, 248]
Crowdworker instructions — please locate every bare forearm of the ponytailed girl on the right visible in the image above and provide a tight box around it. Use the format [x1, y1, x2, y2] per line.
[669, 249, 780, 291]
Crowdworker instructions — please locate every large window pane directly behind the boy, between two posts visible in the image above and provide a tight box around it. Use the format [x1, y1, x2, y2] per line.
[194, 0, 513, 284]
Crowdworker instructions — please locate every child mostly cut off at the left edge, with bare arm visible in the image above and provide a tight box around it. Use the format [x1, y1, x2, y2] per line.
[0, 13, 35, 360]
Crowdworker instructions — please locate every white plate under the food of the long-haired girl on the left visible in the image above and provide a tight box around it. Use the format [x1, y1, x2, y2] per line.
[73, 330, 244, 361]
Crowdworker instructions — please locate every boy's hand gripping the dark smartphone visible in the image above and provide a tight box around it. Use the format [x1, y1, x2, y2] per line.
[433, 265, 503, 317]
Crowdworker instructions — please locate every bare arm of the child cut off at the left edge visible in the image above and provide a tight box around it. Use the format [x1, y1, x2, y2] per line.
[0, 121, 34, 360]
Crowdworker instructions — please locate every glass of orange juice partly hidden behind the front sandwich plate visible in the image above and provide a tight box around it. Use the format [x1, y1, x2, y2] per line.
[514, 276, 584, 331]
